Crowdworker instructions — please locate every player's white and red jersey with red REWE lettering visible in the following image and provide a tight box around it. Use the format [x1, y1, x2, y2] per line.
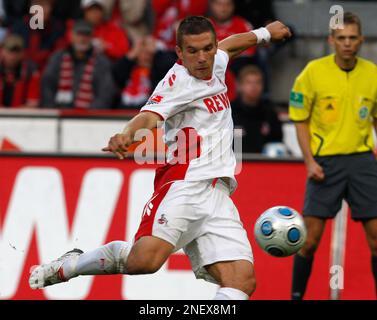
[141, 50, 237, 192]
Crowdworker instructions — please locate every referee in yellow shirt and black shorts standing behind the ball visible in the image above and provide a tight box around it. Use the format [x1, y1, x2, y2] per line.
[289, 12, 377, 300]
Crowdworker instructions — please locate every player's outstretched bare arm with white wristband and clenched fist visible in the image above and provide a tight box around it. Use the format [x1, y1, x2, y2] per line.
[219, 21, 292, 59]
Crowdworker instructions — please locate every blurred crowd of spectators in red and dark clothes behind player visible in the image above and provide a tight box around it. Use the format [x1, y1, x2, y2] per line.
[0, 0, 290, 152]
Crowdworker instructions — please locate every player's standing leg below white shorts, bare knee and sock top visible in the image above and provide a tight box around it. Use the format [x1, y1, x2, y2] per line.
[205, 260, 256, 300]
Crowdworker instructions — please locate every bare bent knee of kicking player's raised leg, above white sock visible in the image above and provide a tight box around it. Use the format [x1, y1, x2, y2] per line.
[125, 236, 174, 275]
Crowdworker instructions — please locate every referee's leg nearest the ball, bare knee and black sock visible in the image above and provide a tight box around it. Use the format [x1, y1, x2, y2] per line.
[291, 216, 326, 300]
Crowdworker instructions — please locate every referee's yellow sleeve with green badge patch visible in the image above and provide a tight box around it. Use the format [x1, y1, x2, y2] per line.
[289, 65, 314, 121]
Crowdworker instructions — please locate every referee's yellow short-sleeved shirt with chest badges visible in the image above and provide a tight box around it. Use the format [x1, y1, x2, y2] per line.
[289, 54, 377, 156]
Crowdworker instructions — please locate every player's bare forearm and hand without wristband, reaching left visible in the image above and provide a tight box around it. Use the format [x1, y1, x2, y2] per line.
[102, 111, 161, 160]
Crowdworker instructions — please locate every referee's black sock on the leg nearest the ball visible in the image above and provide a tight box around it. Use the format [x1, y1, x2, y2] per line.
[291, 254, 313, 300]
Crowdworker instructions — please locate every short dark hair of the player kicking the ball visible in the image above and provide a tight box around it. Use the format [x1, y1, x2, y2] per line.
[177, 16, 216, 48]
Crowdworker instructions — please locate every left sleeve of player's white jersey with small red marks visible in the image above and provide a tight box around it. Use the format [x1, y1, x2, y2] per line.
[140, 71, 193, 121]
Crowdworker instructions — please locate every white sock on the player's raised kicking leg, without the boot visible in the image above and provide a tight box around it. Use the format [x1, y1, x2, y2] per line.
[62, 241, 131, 280]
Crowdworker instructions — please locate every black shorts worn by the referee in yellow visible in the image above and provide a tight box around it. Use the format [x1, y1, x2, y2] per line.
[304, 152, 377, 220]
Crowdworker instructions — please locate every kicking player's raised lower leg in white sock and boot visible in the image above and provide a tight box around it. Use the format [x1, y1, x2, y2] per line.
[29, 241, 131, 289]
